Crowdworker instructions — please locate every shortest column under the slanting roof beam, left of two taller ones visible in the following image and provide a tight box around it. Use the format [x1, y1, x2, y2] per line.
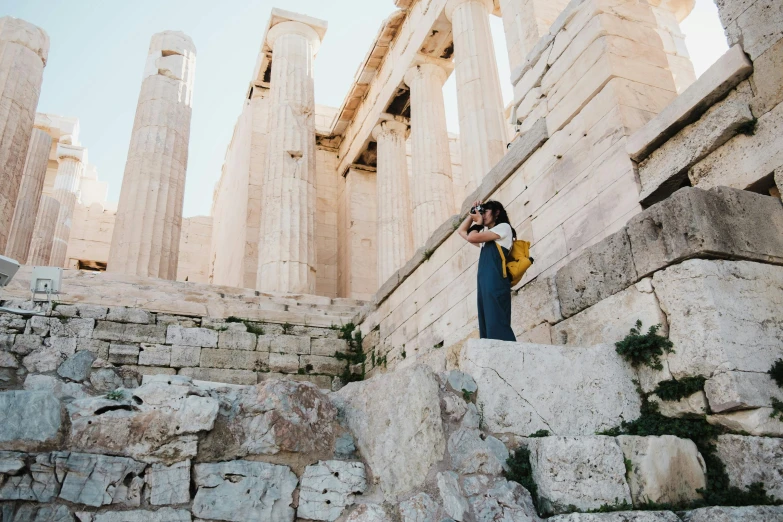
[372, 116, 413, 285]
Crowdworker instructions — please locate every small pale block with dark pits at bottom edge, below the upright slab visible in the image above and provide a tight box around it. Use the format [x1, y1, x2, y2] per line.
[296, 460, 367, 521]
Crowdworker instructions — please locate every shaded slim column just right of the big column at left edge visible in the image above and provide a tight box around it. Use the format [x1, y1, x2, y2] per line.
[5, 129, 52, 263]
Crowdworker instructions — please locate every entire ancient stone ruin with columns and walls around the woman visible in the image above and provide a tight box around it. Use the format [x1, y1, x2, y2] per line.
[0, 0, 783, 522]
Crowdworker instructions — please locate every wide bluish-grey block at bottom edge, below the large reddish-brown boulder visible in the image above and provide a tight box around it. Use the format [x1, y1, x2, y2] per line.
[192, 460, 298, 522]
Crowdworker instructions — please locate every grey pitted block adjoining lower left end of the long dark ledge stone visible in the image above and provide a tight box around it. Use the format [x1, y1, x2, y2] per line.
[555, 228, 638, 318]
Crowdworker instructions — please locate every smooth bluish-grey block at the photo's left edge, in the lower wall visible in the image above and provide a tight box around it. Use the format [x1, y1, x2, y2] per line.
[0, 391, 62, 451]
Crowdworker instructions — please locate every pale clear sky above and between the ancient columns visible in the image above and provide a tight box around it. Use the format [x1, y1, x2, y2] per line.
[0, 0, 726, 217]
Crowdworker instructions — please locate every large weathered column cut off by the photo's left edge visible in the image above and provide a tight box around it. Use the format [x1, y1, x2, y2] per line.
[0, 16, 49, 252]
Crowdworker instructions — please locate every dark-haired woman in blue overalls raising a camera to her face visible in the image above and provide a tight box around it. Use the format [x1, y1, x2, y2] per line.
[458, 201, 517, 341]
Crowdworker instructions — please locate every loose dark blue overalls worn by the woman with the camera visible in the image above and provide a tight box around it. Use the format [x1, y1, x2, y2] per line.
[476, 241, 517, 341]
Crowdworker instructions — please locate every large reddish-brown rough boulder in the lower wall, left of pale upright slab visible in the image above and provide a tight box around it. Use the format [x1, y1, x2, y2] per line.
[199, 380, 337, 460]
